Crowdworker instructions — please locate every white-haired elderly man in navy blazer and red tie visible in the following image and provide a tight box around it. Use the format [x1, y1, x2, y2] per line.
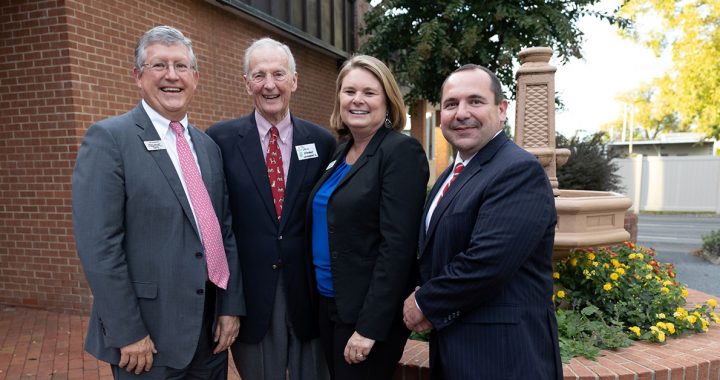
[207, 38, 335, 380]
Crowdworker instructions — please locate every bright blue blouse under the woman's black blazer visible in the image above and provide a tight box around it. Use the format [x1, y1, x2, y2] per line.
[312, 160, 352, 297]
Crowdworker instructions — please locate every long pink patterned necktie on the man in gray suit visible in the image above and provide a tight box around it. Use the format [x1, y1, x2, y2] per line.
[170, 121, 230, 289]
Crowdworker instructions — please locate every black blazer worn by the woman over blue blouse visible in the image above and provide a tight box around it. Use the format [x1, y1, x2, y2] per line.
[307, 127, 428, 341]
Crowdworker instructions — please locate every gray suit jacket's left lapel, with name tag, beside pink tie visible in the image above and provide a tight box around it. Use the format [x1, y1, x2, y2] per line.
[133, 105, 198, 236]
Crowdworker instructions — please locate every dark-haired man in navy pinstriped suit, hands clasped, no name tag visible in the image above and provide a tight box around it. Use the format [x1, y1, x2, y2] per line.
[403, 65, 562, 379]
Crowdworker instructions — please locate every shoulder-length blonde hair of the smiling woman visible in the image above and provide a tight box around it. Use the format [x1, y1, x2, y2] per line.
[330, 55, 405, 137]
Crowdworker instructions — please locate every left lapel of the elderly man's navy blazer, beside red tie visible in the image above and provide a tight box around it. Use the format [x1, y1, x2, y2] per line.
[235, 117, 278, 223]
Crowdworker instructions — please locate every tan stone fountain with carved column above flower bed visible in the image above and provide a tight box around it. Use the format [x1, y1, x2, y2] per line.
[515, 47, 632, 261]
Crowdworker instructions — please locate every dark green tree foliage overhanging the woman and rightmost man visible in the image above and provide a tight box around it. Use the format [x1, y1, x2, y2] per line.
[360, 0, 617, 104]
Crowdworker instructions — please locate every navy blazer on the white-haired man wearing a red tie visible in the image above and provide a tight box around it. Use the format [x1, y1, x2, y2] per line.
[207, 112, 336, 343]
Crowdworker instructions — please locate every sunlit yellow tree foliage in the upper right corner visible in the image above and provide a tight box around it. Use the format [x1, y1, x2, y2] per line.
[617, 0, 720, 138]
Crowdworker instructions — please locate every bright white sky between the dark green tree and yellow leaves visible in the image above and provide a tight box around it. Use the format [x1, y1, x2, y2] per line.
[548, 0, 671, 137]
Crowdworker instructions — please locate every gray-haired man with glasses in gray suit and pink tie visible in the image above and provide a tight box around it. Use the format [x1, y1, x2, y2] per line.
[72, 26, 245, 379]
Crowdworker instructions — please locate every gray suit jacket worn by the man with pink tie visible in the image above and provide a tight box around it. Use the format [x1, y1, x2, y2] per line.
[72, 105, 245, 368]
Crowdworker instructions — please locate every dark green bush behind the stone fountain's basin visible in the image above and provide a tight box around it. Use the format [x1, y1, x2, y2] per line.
[555, 132, 622, 192]
